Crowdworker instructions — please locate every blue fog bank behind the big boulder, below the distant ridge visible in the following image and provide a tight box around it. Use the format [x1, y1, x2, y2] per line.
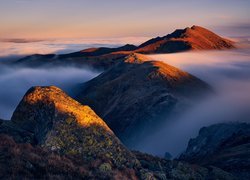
[0, 67, 99, 119]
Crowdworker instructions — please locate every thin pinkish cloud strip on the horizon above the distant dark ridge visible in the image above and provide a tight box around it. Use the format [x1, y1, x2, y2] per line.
[0, 37, 149, 59]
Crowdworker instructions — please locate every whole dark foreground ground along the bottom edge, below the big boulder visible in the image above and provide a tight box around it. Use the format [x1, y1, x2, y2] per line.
[0, 135, 234, 180]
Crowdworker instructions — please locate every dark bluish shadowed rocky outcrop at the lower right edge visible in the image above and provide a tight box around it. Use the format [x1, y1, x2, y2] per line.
[179, 123, 250, 179]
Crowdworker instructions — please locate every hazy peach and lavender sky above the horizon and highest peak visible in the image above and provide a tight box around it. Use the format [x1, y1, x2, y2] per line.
[0, 0, 250, 38]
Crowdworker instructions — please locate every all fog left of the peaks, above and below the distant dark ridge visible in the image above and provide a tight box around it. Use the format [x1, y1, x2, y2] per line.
[0, 37, 148, 119]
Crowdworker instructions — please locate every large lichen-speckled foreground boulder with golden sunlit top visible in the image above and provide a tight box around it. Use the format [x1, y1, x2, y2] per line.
[11, 86, 135, 167]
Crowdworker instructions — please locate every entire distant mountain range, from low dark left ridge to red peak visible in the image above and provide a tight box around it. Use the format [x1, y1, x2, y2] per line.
[5, 26, 235, 70]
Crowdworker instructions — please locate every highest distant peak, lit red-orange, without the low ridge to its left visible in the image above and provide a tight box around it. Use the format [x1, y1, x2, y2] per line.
[135, 26, 234, 54]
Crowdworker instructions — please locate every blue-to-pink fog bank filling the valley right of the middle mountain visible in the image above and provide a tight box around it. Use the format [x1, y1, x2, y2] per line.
[136, 43, 250, 157]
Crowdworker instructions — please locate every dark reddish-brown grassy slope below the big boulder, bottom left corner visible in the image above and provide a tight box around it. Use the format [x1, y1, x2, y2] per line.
[0, 135, 138, 179]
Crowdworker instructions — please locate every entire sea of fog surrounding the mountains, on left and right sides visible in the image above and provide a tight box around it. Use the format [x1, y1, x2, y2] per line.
[0, 40, 250, 157]
